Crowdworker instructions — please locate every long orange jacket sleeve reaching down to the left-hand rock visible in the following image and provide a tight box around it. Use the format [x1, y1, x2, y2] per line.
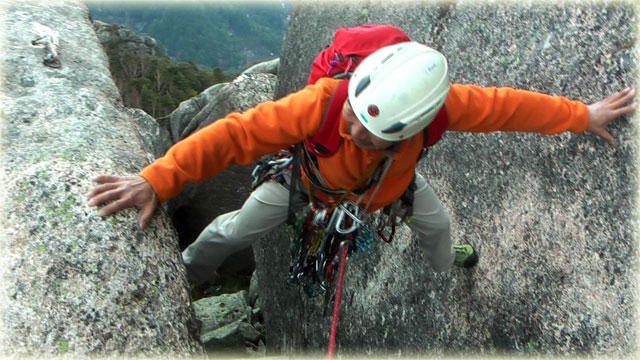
[140, 81, 332, 202]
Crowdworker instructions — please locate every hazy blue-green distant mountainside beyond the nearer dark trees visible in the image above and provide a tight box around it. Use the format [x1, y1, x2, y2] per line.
[87, 0, 291, 73]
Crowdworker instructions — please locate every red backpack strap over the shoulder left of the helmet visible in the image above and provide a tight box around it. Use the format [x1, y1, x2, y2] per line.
[304, 80, 349, 157]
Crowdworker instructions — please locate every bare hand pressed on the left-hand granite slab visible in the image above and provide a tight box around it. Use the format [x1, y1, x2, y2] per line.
[87, 175, 159, 229]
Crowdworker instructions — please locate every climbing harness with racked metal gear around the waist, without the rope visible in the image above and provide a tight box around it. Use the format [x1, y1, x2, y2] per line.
[252, 144, 415, 298]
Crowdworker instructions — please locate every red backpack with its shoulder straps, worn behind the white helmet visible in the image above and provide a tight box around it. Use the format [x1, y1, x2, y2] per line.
[305, 25, 449, 157]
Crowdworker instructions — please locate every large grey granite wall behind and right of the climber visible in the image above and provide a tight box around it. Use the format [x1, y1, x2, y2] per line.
[254, 1, 638, 356]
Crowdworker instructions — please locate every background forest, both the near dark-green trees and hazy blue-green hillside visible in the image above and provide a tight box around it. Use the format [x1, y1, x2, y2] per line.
[87, 0, 289, 118]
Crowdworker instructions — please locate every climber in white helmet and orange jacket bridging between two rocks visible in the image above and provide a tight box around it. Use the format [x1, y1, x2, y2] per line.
[88, 42, 637, 292]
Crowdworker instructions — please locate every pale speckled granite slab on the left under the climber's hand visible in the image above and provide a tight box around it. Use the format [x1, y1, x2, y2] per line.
[0, 1, 202, 357]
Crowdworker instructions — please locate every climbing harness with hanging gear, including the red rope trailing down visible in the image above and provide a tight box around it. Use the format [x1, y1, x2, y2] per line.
[278, 146, 415, 359]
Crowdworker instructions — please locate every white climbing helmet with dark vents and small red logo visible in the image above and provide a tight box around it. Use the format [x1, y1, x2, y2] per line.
[349, 41, 449, 141]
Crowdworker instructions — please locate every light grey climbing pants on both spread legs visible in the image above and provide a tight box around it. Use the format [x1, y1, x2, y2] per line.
[182, 174, 455, 285]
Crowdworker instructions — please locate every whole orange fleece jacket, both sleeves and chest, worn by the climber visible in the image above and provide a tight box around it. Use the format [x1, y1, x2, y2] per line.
[140, 78, 589, 211]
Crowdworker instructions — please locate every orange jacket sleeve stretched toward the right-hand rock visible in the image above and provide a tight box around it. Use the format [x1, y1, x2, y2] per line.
[445, 84, 589, 134]
